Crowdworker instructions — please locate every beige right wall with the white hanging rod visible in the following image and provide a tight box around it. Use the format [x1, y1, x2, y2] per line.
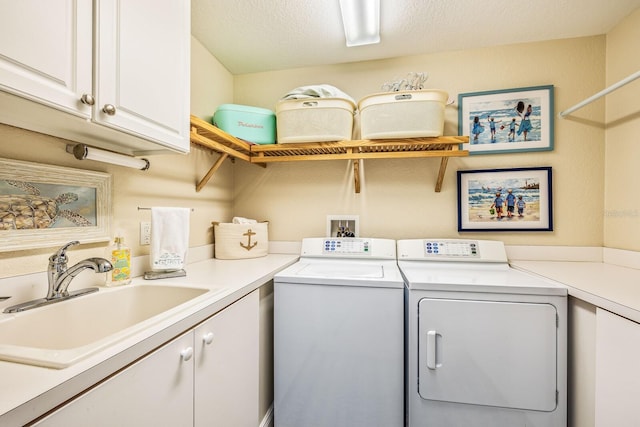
[604, 9, 640, 251]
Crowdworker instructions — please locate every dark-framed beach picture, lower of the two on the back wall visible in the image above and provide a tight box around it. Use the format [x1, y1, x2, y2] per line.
[458, 167, 553, 231]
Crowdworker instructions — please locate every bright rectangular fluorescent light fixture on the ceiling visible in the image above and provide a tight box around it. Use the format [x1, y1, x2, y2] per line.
[340, 0, 380, 47]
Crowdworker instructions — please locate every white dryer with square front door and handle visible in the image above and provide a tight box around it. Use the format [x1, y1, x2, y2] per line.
[397, 239, 567, 427]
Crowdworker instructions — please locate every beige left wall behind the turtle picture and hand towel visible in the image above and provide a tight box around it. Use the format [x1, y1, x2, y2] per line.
[0, 39, 233, 278]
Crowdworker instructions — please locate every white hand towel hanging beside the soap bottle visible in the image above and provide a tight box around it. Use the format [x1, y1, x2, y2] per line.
[151, 207, 191, 271]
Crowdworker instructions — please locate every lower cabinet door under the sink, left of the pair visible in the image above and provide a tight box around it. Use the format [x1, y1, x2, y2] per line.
[35, 332, 194, 427]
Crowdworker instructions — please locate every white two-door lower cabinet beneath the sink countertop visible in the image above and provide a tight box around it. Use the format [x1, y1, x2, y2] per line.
[33, 290, 259, 427]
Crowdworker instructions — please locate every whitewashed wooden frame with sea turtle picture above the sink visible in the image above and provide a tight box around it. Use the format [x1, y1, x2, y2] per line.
[0, 158, 111, 252]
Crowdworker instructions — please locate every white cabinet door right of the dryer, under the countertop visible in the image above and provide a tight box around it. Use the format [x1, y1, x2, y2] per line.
[595, 308, 640, 427]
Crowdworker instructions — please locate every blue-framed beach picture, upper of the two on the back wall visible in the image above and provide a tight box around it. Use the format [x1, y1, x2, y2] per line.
[458, 86, 554, 154]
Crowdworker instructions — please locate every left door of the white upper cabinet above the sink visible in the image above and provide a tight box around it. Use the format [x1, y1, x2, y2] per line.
[0, 0, 92, 118]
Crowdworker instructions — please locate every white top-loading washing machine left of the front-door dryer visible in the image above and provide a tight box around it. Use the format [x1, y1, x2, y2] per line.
[274, 238, 404, 427]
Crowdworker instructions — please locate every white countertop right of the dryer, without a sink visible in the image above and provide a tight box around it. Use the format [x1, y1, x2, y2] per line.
[510, 261, 640, 323]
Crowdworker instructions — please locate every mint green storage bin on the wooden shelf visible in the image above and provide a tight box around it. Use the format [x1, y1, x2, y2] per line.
[211, 104, 276, 144]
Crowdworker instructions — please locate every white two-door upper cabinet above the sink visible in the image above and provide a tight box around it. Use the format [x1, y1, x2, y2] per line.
[0, 0, 191, 154]
